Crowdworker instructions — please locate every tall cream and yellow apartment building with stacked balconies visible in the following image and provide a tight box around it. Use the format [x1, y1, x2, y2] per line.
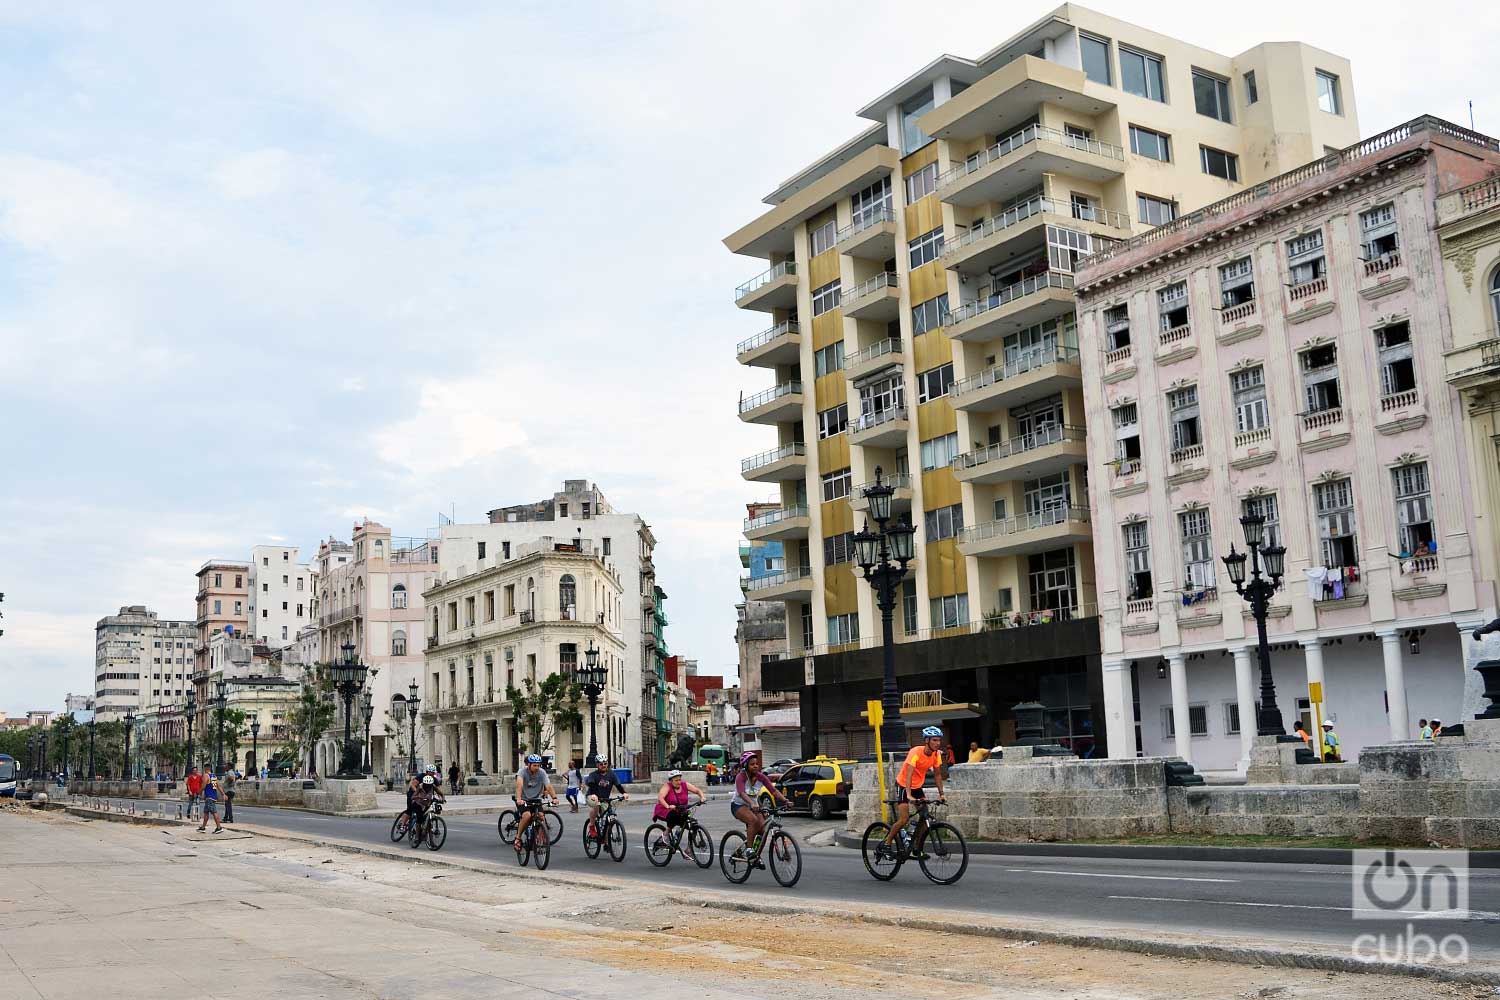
[726, 4, 1358, 753]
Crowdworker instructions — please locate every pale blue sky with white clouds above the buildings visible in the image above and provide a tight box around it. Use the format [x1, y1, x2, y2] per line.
[0, 0, 1500, 714]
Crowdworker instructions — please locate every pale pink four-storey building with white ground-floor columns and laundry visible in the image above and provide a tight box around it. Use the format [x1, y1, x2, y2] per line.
[1077, 118, 1500, 771]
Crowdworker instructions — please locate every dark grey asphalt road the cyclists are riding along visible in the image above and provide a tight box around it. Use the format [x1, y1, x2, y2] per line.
[79, 799, 1500, 963]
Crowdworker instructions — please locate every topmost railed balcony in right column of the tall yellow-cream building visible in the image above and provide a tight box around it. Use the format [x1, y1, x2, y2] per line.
[938, 124, 1125, 207]
